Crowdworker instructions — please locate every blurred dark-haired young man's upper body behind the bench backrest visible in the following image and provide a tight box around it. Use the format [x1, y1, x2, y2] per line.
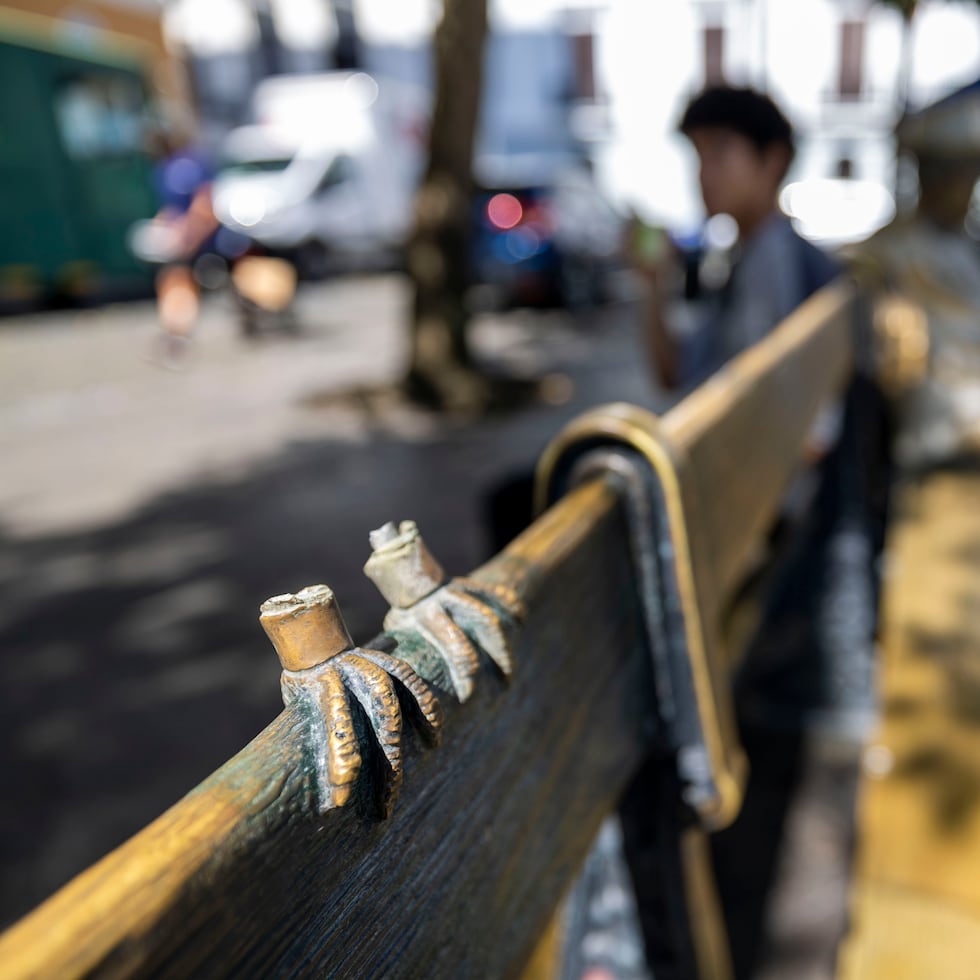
[631, 86, 838, 389]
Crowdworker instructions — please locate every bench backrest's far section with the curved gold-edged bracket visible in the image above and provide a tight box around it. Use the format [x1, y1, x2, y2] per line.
[535, 279, 858, 829]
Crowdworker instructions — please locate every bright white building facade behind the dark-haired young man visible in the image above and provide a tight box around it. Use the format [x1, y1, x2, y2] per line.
[598, 0, 980, 235]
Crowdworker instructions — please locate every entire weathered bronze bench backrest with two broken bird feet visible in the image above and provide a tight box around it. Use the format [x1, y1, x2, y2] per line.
[0, 278, 853, 978]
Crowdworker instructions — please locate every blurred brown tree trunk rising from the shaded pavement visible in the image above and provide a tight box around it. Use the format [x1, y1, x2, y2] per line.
[407, 0, 488, 411]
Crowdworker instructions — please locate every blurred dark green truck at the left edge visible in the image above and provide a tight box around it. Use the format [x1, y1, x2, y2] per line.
[0, 31, 156, 311]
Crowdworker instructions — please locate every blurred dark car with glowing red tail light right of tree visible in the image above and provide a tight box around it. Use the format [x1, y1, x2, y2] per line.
[472, 164, 623, 308]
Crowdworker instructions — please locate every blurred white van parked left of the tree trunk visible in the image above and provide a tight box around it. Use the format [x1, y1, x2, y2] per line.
[214, 72, 428, 276]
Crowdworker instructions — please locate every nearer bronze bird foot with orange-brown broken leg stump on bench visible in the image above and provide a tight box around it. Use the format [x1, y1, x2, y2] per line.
[259, 585, 442, 815]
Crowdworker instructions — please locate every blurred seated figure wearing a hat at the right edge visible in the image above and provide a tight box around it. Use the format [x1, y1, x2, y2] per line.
[850, 79, 980, 469]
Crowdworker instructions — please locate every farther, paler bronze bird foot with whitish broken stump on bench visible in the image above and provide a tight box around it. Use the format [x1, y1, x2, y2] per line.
[364, 521, 522, 701]
